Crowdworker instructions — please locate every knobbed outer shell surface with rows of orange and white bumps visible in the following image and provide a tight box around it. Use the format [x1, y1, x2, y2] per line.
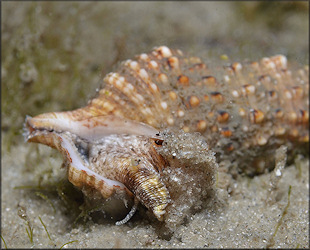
[88, 46, 309, 175]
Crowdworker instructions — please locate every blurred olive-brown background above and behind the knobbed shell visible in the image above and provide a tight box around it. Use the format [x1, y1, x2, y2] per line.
[1, 1, 309, 148]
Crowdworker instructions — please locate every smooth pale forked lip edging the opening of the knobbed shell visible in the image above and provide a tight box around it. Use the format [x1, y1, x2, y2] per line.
[23, 112, 158, 195]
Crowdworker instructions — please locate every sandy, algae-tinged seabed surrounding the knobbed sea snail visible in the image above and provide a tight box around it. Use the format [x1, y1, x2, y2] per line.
[1, 1, 309, 248]
